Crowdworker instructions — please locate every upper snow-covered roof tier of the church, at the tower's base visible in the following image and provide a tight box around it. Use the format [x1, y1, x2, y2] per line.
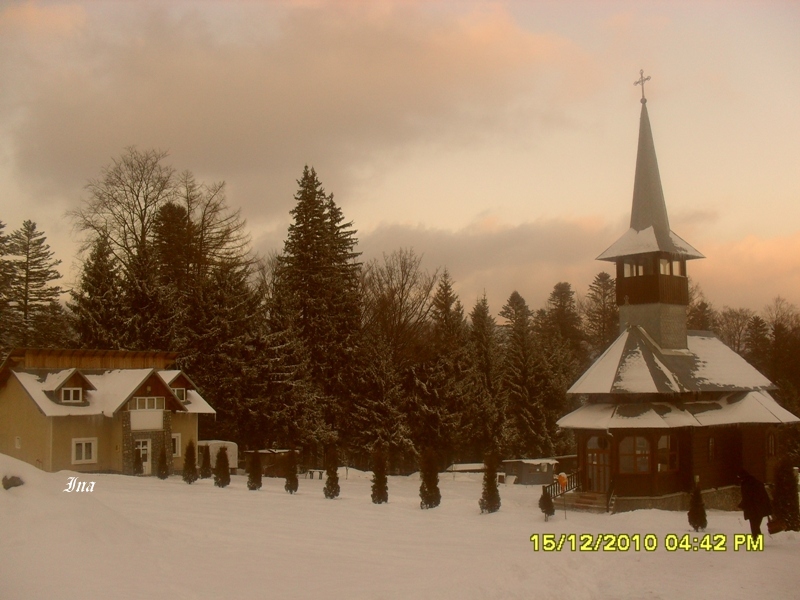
[567, 326, 775, 395]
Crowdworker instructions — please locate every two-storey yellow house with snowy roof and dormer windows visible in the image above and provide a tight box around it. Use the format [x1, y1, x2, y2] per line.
[0, 349, 215, 474]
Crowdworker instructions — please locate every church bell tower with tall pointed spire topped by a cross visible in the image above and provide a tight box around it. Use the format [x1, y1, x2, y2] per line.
[597, 71, 705, 350]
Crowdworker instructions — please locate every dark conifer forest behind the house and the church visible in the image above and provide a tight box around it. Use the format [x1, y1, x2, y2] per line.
[0, 148, 800, 472]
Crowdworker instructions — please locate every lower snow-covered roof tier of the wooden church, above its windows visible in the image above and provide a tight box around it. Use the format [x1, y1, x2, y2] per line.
[558, 390, 800, 430]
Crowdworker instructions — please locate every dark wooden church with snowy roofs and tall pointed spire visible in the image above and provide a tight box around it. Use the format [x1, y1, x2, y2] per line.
[558, 74, 800, 511]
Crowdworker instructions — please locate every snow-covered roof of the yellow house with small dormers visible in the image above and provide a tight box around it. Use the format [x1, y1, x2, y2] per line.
[11, 368, 215, 417]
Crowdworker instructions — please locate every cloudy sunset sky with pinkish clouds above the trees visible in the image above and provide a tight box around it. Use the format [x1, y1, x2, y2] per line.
[0, 0, 800, 312]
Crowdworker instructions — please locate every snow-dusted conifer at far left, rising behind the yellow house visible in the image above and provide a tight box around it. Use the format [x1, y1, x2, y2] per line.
[8, 221, 66, 347]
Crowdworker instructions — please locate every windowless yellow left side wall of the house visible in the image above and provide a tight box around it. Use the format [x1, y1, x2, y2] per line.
[0, 376, 52, 471]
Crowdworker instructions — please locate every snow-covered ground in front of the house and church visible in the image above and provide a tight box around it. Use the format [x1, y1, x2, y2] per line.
[0, 455, 800, 600]
